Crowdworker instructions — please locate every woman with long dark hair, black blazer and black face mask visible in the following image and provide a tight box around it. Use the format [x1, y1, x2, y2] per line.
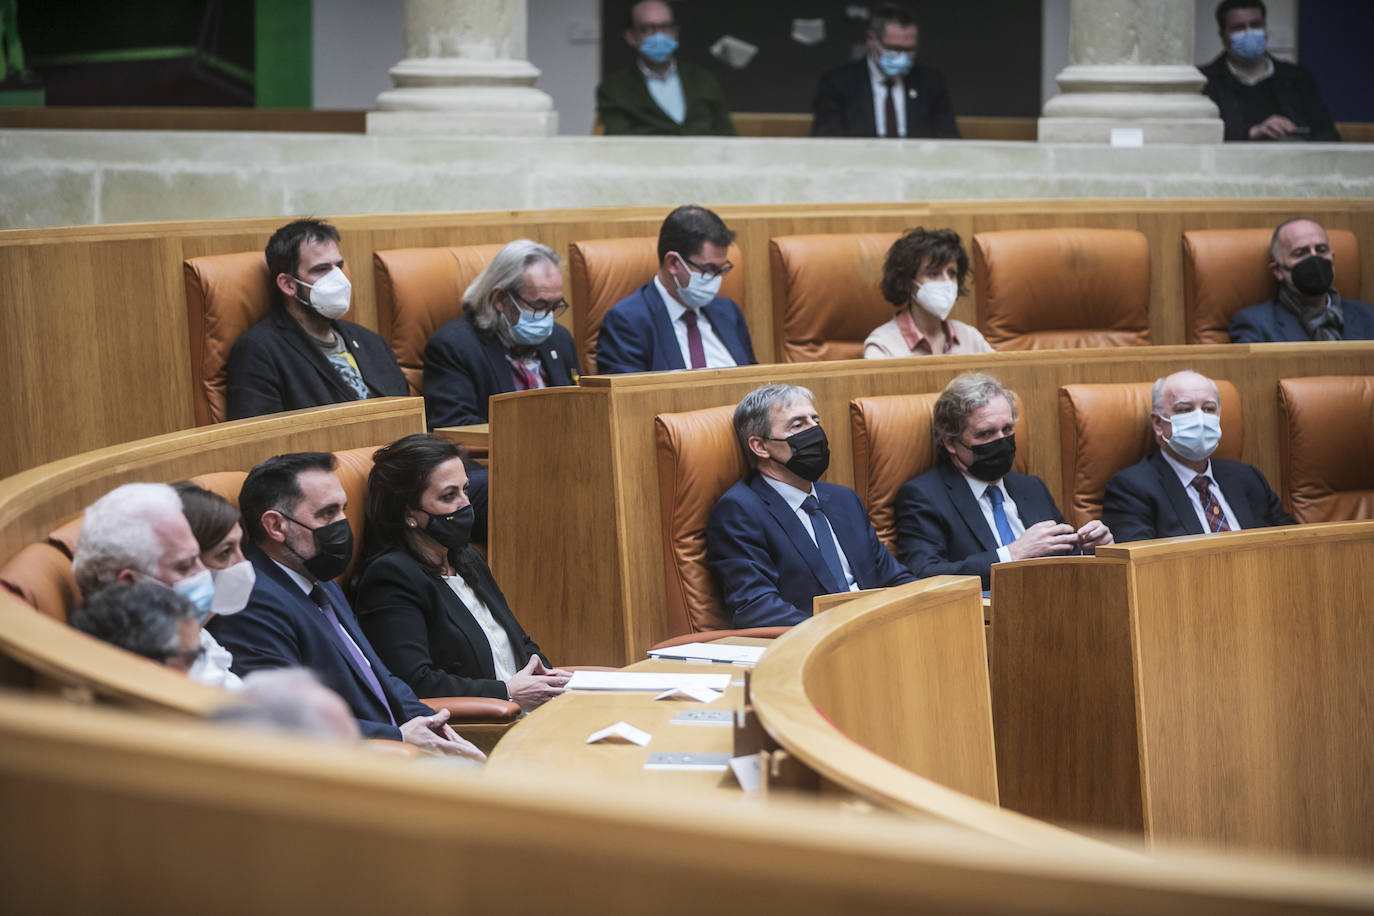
[353, 434, 569, 713]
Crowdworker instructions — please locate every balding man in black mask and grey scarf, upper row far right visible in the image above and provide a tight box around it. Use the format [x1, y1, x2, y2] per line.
[1231, 218, 1374, 343]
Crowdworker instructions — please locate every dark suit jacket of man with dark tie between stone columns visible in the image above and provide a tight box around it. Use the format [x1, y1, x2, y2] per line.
[811, 56, 959, 139]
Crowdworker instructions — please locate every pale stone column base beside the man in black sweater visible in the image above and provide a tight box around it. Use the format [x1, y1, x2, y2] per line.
[1040, 0, 1223, 144]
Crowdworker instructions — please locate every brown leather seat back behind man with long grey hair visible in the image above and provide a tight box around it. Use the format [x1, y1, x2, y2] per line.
[372, 244, 502, 394]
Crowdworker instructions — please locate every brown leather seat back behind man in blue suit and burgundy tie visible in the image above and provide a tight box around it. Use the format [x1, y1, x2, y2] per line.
[567, 236, 745, 375]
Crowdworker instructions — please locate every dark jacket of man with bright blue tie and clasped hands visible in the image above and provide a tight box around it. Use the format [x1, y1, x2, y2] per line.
[894, 463, 1077, 589]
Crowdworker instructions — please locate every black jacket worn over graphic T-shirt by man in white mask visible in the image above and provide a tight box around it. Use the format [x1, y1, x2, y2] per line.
[228, 305, 411, 420]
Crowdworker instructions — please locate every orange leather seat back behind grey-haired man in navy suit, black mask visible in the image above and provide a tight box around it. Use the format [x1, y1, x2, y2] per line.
[654, 404, 749, 636]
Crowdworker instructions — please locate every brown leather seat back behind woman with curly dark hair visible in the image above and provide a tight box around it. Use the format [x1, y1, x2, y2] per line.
[768, 232, 899, 363]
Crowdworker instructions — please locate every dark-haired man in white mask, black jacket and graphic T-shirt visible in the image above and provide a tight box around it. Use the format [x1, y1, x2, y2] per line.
[228, 220, 409, 420]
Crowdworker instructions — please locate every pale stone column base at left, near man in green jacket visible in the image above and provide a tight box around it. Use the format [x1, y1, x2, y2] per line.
[367, 0, 558, 136]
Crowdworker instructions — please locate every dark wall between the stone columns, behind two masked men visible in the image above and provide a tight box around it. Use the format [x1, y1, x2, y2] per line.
[602, 0, 1041, 118]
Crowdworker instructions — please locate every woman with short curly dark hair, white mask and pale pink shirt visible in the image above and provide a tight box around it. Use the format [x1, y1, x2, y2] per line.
[863, 227, 992, 360]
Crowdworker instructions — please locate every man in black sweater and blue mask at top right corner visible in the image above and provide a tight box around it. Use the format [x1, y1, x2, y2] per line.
[1200, 0, 1341, 141]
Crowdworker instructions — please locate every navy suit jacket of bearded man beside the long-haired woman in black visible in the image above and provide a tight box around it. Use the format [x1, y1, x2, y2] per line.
[207, 544, 434, 742]
